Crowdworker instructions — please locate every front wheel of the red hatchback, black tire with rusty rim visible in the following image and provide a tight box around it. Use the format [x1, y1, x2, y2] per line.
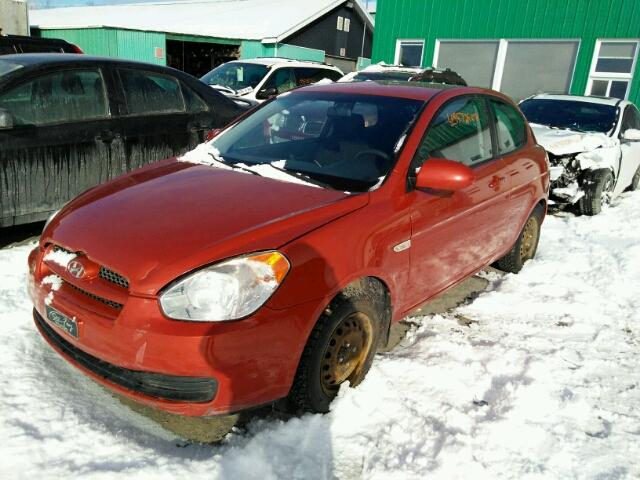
[289, 280, 386, 413]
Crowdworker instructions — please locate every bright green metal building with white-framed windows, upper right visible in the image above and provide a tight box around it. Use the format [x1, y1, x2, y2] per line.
[372, 0, 640, 104]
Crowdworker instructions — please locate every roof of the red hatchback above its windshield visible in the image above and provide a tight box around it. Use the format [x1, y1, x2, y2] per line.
[285, 81, 484, 101]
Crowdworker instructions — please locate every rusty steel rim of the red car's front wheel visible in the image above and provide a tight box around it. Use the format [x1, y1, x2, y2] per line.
[320, 312, 373, 395]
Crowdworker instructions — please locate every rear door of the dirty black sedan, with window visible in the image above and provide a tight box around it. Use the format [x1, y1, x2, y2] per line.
[115, 67, 196, 170]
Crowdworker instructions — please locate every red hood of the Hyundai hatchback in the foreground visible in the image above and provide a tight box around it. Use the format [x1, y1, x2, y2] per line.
[41, 160, 369, 295]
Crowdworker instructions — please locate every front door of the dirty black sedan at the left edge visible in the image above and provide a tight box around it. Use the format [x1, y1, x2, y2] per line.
[0, 66, 122, 225]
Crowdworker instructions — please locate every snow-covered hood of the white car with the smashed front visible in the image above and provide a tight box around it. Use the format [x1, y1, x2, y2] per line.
[530, 123, 618, 155]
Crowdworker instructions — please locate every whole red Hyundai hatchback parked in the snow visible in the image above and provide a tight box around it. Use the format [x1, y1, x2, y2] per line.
[29, 82, 549, 430]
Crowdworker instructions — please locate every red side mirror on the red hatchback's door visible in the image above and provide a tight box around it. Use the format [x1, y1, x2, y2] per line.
[416, 158, 476, 192]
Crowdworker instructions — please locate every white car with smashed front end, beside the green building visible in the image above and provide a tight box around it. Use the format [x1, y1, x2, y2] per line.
[520, 94, 640, 215]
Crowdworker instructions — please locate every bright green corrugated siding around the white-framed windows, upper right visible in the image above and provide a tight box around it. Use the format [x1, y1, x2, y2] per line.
[372, 0, 640, 103]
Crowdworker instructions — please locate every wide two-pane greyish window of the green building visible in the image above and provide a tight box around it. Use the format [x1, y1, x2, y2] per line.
[433, 39, 580, 100]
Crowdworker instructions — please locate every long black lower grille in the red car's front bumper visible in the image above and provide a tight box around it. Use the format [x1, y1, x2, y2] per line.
[33, 310, 218, 403]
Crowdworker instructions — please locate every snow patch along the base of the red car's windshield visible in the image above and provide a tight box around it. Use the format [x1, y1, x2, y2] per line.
[178, 142, 321, 188]
